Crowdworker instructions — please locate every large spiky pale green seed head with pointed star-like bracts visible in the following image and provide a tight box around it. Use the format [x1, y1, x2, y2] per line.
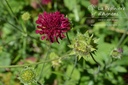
[69, 32, 98, 59]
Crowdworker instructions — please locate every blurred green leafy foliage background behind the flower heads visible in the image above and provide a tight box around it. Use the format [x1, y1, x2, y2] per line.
[0, 0, 128, 85]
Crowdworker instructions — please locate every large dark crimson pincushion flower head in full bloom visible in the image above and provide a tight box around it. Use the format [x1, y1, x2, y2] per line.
[36, 11, 70, 43]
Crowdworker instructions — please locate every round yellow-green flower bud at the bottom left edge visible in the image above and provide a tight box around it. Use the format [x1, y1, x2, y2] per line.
[19, 67, 36, 85]
